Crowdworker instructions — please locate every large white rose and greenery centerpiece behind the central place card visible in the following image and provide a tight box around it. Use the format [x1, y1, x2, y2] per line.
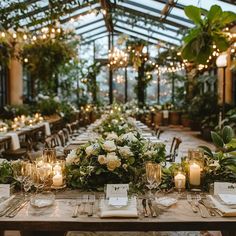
[66, 132, 165, 190]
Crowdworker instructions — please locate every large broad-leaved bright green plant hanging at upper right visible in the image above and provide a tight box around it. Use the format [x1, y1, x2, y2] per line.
[181, 5, 236, 64]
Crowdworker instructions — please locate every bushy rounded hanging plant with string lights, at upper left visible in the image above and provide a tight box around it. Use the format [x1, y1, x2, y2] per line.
[20, 30, 77, 92]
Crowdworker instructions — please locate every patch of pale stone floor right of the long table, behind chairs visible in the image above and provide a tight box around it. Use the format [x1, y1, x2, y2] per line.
[160, 126, 214, 162]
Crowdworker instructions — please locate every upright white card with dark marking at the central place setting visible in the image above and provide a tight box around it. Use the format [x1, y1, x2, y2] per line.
[106, 184, 129, 198]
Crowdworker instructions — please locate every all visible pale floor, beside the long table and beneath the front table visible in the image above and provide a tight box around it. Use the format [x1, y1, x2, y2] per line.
[5, 126, 218, 236]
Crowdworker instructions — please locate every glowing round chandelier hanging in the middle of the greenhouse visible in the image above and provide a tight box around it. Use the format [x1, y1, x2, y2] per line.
[108, 48, 128, 70]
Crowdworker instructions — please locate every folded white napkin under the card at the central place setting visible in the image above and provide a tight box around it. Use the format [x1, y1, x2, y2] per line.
[100, 197, 138, 218]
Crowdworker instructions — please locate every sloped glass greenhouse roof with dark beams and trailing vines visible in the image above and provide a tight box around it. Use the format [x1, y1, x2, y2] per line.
[0, 0, 236, 46]
